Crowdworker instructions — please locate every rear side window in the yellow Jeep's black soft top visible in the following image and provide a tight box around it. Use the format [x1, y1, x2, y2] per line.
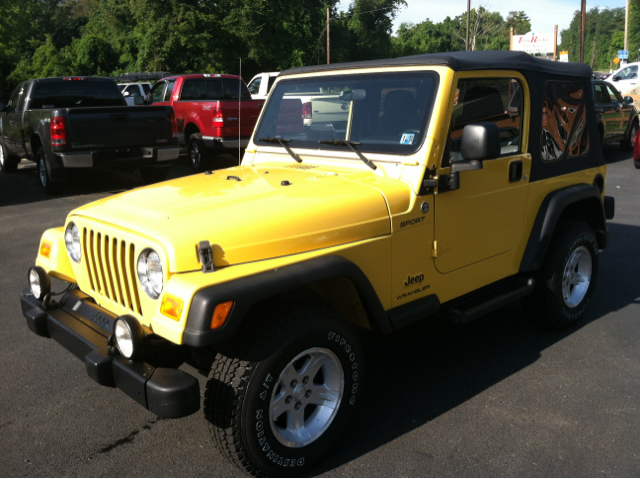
[541, 81, 589, 161]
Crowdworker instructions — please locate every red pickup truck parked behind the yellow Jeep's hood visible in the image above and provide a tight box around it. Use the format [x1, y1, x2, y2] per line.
[145, 73, 264, 171]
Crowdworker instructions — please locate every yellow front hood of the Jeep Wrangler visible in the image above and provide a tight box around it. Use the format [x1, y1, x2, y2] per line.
[72, 165, 390, 273]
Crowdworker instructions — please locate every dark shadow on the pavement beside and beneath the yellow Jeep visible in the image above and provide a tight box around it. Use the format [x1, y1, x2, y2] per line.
[310, 223, 640, 475]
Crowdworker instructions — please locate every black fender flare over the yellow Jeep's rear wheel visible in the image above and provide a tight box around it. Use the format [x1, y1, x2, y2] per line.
[520, 184, 609, 272]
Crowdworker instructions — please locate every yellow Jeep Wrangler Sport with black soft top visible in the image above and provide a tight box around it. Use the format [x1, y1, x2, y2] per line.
[21, 52, 614, 476]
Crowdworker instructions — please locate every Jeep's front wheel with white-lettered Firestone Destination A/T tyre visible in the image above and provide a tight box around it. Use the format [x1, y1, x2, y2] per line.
[204, 307, 363, 477]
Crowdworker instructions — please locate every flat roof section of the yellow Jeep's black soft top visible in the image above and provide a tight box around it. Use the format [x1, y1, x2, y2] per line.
[279, 50, 593, 78]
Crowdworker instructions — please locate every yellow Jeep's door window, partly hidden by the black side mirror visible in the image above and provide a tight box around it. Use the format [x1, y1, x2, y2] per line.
[443, 78, 523, 166]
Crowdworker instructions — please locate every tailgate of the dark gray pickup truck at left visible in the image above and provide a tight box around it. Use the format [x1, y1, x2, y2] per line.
[66, 106, 173, 150]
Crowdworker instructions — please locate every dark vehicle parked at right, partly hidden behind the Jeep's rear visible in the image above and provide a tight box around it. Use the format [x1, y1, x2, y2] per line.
[592, 80, 638, 151]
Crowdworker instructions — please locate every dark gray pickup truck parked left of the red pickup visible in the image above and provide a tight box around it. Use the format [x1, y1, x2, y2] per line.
[0, 77, 180, 194]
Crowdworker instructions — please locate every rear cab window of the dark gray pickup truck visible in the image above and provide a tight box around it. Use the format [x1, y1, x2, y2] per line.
[29, 80, 126, 110]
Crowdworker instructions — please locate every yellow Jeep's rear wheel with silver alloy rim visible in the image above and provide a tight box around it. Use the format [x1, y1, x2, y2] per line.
[523, 220, 599, 329]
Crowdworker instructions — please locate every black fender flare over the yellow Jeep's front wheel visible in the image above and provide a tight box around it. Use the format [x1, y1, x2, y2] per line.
[183, 255, 392, 347]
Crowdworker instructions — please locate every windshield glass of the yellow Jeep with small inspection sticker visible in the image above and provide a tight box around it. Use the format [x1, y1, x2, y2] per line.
[254, 71, 438, 154]
